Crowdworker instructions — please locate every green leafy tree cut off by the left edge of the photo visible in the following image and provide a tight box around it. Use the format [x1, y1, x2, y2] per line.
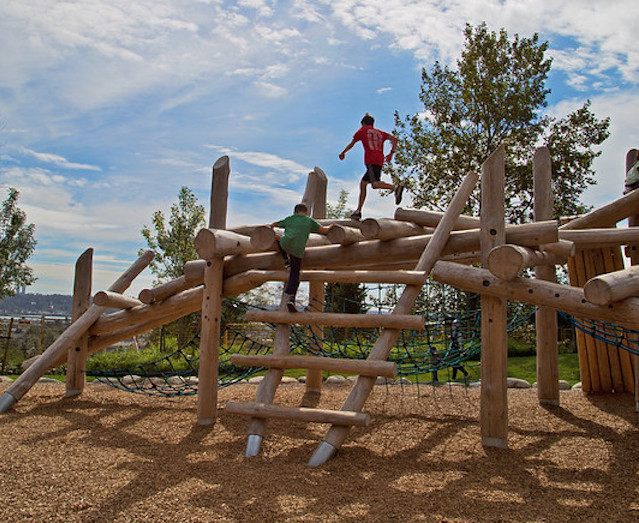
[0, 187, 37, 299]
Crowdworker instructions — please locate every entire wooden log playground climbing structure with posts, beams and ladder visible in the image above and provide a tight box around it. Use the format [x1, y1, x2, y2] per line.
[0, 146, 639, 466]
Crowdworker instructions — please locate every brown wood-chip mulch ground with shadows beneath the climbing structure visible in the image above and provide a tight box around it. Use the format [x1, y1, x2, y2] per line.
[0, 383, 639, 523]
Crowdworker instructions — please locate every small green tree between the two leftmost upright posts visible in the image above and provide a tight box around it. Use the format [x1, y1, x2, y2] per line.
[140, 187, 205, 346]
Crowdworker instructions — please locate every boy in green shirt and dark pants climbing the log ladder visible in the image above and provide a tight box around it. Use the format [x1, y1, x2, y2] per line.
[270, 203, 330, 312]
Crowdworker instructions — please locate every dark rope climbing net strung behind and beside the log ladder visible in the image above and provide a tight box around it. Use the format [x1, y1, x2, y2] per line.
[87, 282, 534, 396]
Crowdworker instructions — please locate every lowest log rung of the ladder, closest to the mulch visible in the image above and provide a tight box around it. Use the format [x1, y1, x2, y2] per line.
[224, 401, 371, 426]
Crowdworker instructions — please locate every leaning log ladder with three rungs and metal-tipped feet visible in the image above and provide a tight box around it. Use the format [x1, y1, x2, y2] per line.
[226, 173, 479, 466]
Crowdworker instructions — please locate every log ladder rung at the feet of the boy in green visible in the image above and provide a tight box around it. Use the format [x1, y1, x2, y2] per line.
[246, 309, 424, 330]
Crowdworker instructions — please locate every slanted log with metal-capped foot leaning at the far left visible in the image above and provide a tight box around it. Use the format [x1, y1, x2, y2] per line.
[5, 251, 153, 408]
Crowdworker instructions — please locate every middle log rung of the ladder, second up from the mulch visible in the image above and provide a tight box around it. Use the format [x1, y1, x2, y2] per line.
[231, 354, 397, 378]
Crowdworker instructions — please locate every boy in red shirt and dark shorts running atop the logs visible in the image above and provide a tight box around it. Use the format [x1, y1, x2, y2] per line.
[339, 113, 404, 220]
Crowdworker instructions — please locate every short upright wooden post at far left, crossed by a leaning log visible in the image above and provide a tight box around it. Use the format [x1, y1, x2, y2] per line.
[65, 249, 93, 397]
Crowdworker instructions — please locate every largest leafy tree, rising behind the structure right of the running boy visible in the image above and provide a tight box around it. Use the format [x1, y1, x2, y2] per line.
[392, 23, 610, 222]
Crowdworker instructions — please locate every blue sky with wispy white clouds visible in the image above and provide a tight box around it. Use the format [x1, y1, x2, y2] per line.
[0, 0, 639, 295]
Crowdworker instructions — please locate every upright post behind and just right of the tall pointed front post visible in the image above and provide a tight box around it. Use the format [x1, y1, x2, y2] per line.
[533, 147, 559, 405]
